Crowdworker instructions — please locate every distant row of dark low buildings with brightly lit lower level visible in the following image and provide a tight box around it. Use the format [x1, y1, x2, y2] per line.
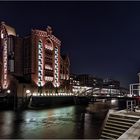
[70, 74, 128, 96]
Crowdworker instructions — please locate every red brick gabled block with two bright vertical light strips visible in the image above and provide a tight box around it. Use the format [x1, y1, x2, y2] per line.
[24, 26, 61, 92]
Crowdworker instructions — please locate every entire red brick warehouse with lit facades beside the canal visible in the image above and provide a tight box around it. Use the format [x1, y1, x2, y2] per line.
[0, 22, 70, 95]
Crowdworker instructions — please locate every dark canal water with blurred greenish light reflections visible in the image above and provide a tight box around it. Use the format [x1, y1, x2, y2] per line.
[0, 99, 118, 139]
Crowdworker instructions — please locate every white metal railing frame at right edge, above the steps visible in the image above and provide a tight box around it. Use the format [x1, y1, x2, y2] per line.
[129, 83, 140, 96]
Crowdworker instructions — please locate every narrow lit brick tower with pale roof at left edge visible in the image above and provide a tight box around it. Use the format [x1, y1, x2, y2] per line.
[0, 22, 16, 90]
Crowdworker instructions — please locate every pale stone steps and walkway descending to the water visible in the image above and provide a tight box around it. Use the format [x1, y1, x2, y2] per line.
[101, 108, 140, 140]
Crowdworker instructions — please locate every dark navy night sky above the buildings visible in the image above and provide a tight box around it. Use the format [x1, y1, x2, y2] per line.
[0, 1, 140, 87]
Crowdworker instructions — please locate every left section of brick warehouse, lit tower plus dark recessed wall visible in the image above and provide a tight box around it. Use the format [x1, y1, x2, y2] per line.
[0, 22, 23, 91]
